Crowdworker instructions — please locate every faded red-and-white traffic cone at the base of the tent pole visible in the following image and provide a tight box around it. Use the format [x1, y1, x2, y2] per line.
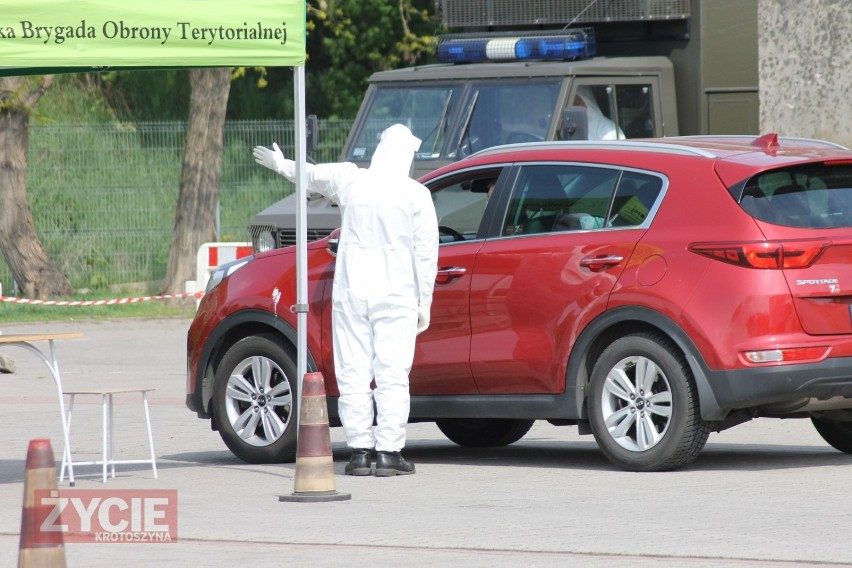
[278, 373, 352, 502]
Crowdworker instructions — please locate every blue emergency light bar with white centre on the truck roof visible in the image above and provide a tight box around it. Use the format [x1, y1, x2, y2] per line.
[438, 28, 597, 63]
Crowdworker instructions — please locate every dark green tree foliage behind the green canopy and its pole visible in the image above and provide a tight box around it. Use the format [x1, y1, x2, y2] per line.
[67, 0, 440, 121]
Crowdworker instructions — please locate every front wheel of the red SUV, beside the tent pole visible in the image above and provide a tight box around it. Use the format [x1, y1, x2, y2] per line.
[213, 335, 298, 463]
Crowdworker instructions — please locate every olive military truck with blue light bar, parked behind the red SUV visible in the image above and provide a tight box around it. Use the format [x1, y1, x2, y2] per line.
[249, 0, 758, 252]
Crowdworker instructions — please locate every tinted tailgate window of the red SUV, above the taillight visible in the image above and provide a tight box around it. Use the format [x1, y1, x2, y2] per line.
[740, 164, 852, 228]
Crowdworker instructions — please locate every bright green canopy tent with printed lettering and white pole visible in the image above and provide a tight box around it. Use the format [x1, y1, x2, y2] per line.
[0, 0, 314, 386]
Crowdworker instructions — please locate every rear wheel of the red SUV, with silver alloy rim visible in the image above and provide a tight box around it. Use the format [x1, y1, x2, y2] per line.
[588, 333, 710, 471]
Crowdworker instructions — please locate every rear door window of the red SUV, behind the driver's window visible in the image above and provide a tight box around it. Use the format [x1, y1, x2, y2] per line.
[502, 165, 620, 236]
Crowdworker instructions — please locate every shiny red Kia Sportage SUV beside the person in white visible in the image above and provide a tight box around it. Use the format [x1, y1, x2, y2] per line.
[187, 134, 852, 471]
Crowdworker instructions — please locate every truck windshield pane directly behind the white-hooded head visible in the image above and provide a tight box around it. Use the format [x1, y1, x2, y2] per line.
[349, 86, 461, 160]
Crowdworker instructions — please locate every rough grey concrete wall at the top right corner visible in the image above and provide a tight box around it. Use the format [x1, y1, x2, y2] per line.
[758, 0, 852, 148]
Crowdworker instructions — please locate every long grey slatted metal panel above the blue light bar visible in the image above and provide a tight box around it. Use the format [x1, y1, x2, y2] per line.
[436, 0, 690, 28]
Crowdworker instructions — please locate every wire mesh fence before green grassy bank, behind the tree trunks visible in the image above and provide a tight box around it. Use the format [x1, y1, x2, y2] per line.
[0, 120, 352, 294]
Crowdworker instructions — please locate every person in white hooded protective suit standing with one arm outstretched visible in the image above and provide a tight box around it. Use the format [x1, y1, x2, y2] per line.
[254, 124, 438, 477]
